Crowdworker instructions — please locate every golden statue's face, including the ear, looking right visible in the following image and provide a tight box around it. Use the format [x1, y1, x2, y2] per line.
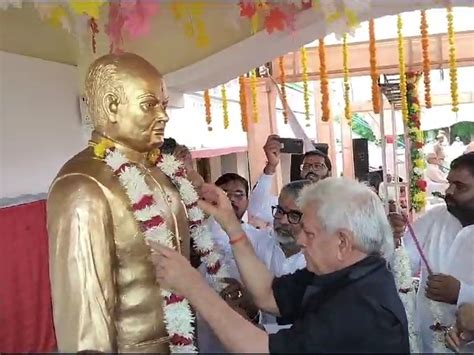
[107, 67, 169, 152]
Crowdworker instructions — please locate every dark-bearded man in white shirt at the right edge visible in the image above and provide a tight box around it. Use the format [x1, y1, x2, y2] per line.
[390, 153, 474, 352]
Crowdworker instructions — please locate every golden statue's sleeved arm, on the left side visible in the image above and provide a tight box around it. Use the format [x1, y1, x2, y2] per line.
[48, 175, 117, 352]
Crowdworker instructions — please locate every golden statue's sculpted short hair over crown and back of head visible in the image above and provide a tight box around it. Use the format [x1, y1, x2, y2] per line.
[85, 53, 164, 131]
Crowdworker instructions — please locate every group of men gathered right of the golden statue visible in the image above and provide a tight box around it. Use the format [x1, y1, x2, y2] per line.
[151, 136, 474, 353]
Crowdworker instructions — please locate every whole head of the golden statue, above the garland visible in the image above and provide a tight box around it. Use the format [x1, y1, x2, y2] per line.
[85, 53, 168, 152]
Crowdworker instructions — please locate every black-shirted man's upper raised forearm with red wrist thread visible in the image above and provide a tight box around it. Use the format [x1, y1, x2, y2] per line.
[199, 184, 279, 315]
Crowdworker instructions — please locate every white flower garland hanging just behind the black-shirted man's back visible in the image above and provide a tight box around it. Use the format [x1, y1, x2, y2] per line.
[392, 246, 420, 354]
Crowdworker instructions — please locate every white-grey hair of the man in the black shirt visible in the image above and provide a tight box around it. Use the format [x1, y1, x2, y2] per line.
[298, 178, 394, 260]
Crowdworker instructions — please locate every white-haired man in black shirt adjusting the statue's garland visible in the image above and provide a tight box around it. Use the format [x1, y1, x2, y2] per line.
[153, 178, 409, 353]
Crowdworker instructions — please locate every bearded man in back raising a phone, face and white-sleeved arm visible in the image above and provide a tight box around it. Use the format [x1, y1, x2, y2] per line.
[248, 135, 332, 224]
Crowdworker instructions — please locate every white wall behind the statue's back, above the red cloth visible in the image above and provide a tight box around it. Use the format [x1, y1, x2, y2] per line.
[0, 51, 87, 198]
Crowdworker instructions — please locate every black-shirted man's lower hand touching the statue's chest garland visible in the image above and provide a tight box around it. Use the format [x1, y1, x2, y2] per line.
[149, 242, 205, 298]
